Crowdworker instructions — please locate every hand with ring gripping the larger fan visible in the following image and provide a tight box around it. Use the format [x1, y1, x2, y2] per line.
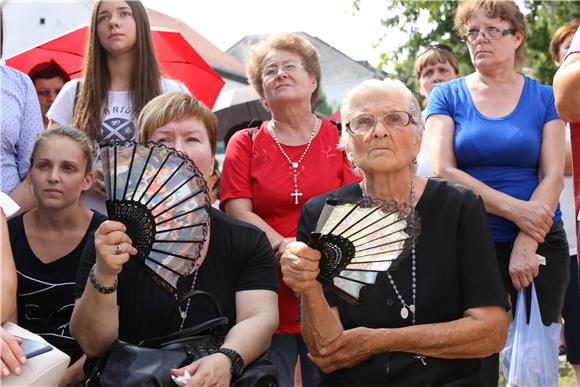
[95, 220, 137, 286]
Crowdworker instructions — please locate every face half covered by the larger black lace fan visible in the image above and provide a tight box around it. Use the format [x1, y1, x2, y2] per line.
[150, 118, 214, 181]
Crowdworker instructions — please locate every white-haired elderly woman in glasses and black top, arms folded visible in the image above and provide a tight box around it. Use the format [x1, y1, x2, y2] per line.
[281, 79, 507, 386]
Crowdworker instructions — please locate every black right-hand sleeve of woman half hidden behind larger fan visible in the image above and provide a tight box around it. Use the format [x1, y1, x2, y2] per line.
[236, 228, 278, 292]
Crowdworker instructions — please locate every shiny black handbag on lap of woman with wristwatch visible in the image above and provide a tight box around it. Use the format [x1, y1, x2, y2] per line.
[86, 290, 278, 387]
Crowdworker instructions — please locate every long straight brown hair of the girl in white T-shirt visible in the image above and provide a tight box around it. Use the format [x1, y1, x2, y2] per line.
[73, 0, 161, 140]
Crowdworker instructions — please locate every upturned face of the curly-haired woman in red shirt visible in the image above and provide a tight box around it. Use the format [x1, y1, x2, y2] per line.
[262, 50, 317, 108]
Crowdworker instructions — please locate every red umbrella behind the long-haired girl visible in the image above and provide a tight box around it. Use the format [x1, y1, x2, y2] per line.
[6, 27, 224, 109]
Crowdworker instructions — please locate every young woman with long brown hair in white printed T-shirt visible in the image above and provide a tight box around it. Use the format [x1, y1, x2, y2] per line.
[47, 0, 187, 211]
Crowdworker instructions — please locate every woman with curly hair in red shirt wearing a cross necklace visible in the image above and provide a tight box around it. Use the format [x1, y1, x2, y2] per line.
[220, 33, 357, 387]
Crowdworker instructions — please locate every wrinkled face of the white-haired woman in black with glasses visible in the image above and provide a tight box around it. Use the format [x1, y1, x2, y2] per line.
[347, 93, 421, 174]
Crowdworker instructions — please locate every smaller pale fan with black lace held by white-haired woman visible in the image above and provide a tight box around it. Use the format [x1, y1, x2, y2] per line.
[308, 197, 419, 304]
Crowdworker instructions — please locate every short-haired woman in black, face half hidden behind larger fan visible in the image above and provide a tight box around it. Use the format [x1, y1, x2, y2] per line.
[71, 93, 278, 386]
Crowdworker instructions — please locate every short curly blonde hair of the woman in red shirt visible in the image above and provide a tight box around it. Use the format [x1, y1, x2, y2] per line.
[247, 33, 321, 108]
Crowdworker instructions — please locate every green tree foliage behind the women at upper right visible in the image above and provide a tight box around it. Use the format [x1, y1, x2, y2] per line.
[360, 0, 580, 94]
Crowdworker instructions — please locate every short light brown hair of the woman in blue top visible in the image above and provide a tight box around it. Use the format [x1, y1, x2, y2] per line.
[454, 0, 527, 67]
